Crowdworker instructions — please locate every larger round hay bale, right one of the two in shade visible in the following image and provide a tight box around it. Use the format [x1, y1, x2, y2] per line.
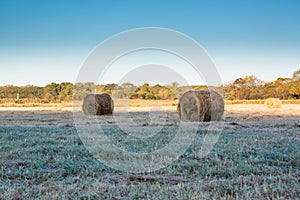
[177, 90, 224, 122]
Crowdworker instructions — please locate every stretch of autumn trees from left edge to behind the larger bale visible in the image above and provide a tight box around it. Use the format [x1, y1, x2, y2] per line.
[0, 82, 206, 103]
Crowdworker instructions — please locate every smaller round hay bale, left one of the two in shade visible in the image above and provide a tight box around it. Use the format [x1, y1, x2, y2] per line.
[82, 94, 114, 115]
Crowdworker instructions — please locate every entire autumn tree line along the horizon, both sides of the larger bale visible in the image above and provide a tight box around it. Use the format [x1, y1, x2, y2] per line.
[0, 70, 300, 103]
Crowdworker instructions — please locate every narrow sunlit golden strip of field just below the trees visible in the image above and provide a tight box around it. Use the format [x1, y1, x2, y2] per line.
[0, 99, 300, 107]
